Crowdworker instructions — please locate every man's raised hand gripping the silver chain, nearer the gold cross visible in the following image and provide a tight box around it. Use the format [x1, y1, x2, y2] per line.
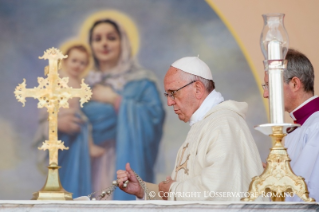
[116, 163, 144, 199]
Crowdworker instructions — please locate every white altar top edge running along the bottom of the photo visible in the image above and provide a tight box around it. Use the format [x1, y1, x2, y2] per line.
[0, 200, 319, 212]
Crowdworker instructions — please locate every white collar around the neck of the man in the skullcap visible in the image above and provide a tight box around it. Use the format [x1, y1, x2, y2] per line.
[189, 90, 224, 126]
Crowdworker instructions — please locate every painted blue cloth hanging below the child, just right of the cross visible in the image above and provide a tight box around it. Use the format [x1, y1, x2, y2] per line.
[58, 116, 92, 198]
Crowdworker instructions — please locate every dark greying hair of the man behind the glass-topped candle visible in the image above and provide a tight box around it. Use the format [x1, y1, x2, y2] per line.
[284, 49, 315, 93]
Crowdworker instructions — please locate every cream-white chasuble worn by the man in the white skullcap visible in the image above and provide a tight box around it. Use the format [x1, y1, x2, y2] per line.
[169, 101, 263, 201]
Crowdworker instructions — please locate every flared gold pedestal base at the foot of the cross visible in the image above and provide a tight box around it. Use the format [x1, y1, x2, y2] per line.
[32, 164, 72, 200]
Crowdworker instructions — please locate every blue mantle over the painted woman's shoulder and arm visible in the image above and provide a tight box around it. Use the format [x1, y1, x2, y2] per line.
[83, 79, 165, 200]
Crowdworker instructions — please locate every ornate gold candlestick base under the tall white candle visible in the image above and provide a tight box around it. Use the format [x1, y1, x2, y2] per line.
[241, 132, 315, 202]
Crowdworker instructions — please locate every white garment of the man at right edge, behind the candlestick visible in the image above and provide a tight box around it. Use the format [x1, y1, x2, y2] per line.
[285, 96, 319, 202]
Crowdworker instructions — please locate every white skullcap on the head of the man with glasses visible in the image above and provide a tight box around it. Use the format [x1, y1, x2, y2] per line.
[171, 57, 213, 80]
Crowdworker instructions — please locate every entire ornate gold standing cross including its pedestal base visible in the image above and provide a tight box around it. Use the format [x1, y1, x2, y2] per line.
[14, 47, 92, 200]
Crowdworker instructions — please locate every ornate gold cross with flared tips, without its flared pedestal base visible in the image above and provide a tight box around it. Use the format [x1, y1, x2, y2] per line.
[14, 47, 92, 166]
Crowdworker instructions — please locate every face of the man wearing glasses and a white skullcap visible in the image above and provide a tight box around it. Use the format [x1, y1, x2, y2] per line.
[164, 67, 197, 122]
